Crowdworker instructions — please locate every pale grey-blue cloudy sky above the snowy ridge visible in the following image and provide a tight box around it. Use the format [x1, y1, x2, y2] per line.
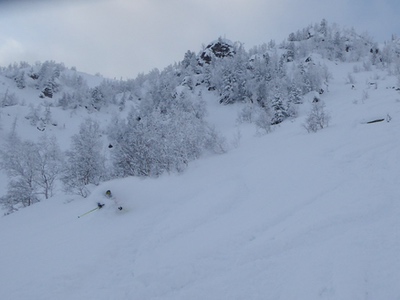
[0, 0, 400, 79]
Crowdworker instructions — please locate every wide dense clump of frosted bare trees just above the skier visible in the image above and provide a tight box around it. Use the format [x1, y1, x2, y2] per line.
[109, 94, 222, 177]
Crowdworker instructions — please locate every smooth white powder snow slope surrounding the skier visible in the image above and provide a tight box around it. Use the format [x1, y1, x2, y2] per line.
[0, 62, 400, 300]
